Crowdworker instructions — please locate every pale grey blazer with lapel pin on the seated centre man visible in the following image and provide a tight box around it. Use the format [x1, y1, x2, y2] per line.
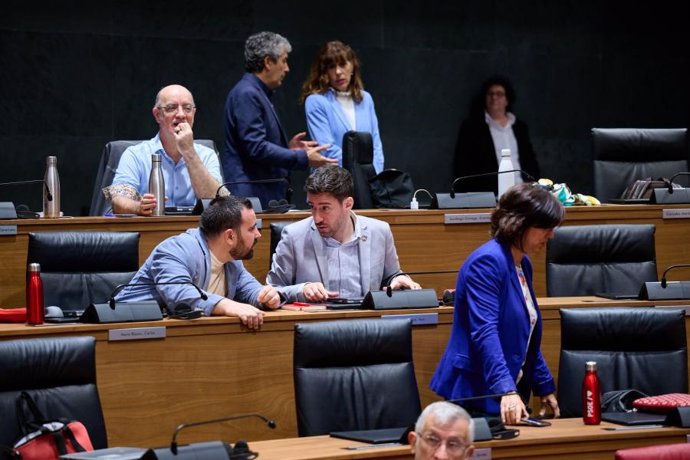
[266, 216, 400, 301]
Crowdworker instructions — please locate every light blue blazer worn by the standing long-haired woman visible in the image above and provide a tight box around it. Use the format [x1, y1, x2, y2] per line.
[304, 89, 383, 173]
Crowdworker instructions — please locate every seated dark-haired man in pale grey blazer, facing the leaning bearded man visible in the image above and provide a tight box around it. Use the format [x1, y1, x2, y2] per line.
[266, 166, 420, 302]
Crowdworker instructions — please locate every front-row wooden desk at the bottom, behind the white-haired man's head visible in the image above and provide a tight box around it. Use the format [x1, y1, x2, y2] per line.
[249, 419, 690, 460]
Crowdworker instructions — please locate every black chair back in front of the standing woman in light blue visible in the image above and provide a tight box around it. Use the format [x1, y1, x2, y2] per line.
[343, 131, 376, 209]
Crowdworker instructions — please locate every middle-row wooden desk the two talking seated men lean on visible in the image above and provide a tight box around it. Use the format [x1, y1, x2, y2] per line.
[0, 297, 690, 447]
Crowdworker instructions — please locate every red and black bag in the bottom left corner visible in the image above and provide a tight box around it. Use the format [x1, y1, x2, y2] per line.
[14, 391, 93, 460]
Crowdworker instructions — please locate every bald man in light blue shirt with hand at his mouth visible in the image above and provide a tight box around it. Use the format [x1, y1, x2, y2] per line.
[104, 85, 223, 216]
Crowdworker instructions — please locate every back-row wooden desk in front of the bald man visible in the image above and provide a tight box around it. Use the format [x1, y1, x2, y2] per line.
[0, 205, 690, 307]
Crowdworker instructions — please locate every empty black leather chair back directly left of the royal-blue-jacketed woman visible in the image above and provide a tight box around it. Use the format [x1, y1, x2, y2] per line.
[293, 319, 421, 436]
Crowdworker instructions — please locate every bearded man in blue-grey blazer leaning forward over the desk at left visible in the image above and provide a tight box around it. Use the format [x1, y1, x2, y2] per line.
[115, 195, 281, 329]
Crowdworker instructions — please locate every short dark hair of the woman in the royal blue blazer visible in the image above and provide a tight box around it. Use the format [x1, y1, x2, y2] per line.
[491, 183, 565, 248]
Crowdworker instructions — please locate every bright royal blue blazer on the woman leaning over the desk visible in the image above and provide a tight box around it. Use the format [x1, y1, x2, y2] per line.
[431, 240, 555, 414]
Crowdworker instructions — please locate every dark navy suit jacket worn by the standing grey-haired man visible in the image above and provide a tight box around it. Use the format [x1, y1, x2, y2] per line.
[221, 73, 308, 207]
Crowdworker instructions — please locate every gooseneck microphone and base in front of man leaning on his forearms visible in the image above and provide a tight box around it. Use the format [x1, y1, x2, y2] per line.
[80, 281, 208, 324]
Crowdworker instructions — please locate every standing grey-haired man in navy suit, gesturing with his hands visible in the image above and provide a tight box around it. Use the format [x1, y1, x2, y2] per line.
[221, 32, 337, 207]
